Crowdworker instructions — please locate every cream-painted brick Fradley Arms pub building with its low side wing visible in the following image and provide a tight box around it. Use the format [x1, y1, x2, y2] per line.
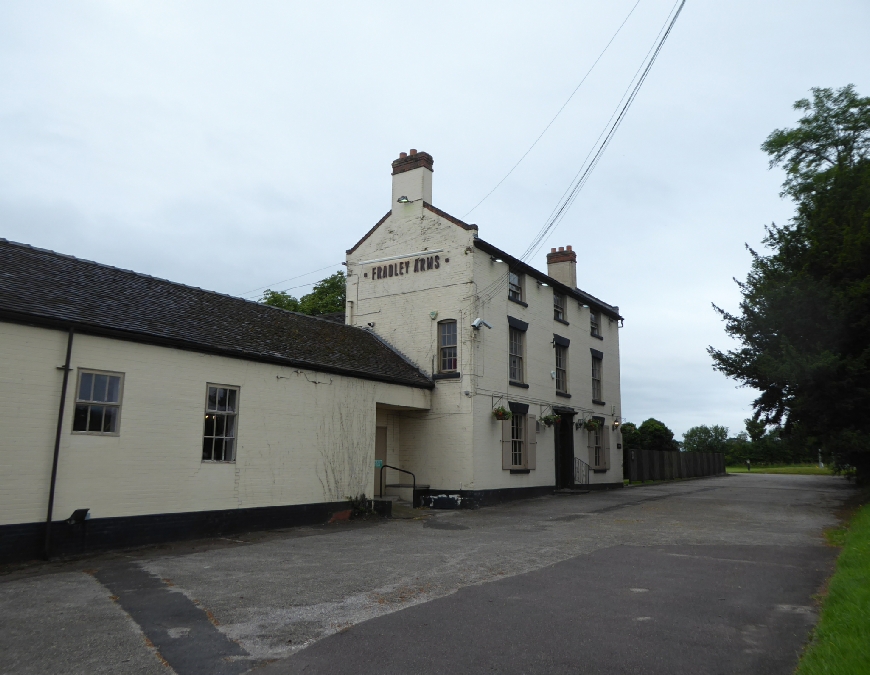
[0, 150, 622, 562]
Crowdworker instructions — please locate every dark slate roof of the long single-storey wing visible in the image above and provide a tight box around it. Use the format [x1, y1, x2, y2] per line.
[0, 238, 434, 388]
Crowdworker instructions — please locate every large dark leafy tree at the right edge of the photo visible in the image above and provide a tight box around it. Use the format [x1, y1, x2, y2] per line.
[708, 85, 870, 482]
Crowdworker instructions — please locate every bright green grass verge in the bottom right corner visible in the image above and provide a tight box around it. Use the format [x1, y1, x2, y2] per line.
[795, 505, 870, 675]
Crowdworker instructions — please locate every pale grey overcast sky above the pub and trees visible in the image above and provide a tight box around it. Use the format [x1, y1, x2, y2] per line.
[0, 0, 870, 438]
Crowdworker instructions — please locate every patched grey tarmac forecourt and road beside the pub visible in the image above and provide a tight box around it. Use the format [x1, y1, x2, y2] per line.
[0, 474, 853, 675]
